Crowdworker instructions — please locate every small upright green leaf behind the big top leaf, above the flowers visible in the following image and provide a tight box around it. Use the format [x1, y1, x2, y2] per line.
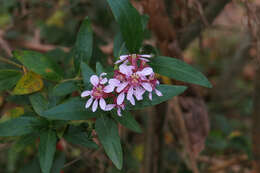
[113, 32, 129, 60]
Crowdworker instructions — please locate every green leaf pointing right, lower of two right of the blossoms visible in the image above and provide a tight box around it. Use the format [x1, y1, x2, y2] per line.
[126, 85, 187, 110]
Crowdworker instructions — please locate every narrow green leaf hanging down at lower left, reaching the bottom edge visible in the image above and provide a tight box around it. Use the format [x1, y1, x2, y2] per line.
[38, 129, 57, 173]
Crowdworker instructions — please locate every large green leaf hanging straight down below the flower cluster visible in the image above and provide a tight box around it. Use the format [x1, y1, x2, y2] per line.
[95, 115, 123, 169]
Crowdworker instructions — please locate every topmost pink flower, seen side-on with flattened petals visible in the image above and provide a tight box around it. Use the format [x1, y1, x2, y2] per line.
[115, 54, 152, 66]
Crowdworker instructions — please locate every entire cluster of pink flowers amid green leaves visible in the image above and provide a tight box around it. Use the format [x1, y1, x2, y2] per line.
[81, 54, 162, 116]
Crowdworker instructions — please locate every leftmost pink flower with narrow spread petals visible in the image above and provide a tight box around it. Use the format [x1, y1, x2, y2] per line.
[81, 73, 109, 112]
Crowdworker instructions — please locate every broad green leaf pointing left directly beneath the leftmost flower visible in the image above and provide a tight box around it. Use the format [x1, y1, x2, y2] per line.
[42, 97, 97, 120]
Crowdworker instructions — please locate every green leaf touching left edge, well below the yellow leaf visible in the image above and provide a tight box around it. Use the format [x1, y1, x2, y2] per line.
[0, 116, 39, 136]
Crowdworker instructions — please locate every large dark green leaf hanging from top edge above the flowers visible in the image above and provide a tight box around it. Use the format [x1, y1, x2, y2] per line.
[107, 0, 143, 53]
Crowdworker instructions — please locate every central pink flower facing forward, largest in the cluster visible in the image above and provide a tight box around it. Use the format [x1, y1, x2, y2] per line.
[116, 64, 153, 105]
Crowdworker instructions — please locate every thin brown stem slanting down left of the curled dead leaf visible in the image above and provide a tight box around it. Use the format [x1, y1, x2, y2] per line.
[169, 97, 199, 173]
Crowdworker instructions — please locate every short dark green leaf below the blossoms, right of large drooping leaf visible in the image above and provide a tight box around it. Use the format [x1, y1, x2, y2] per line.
[111, 111, 142, 133]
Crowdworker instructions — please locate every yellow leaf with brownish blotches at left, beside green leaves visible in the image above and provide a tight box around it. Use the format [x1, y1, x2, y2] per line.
[13, 72, 43, 95]
